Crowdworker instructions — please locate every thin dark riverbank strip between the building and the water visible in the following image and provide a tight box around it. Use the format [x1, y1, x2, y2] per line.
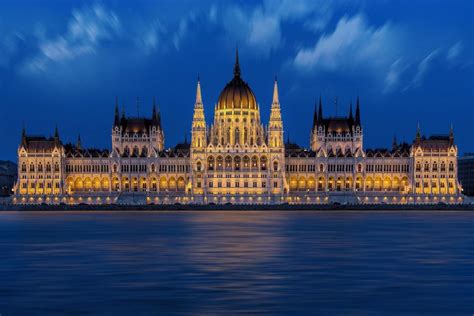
[0, 204, 474, 211]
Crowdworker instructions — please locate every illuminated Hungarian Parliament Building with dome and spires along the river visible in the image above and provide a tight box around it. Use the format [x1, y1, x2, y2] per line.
[13, 51, 463, 205]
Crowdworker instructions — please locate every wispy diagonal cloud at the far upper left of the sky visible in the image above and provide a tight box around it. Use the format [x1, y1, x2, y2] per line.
[23, 4, 121, 72]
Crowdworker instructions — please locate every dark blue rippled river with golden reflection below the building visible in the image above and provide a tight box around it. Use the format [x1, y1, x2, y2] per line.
[0, 211, 474, 316]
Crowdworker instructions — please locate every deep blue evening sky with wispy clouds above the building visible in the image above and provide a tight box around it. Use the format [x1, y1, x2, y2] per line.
[0, 0, 474, 160]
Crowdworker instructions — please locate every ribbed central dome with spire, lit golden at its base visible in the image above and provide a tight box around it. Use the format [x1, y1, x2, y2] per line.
[217, 53, 257, 110]
